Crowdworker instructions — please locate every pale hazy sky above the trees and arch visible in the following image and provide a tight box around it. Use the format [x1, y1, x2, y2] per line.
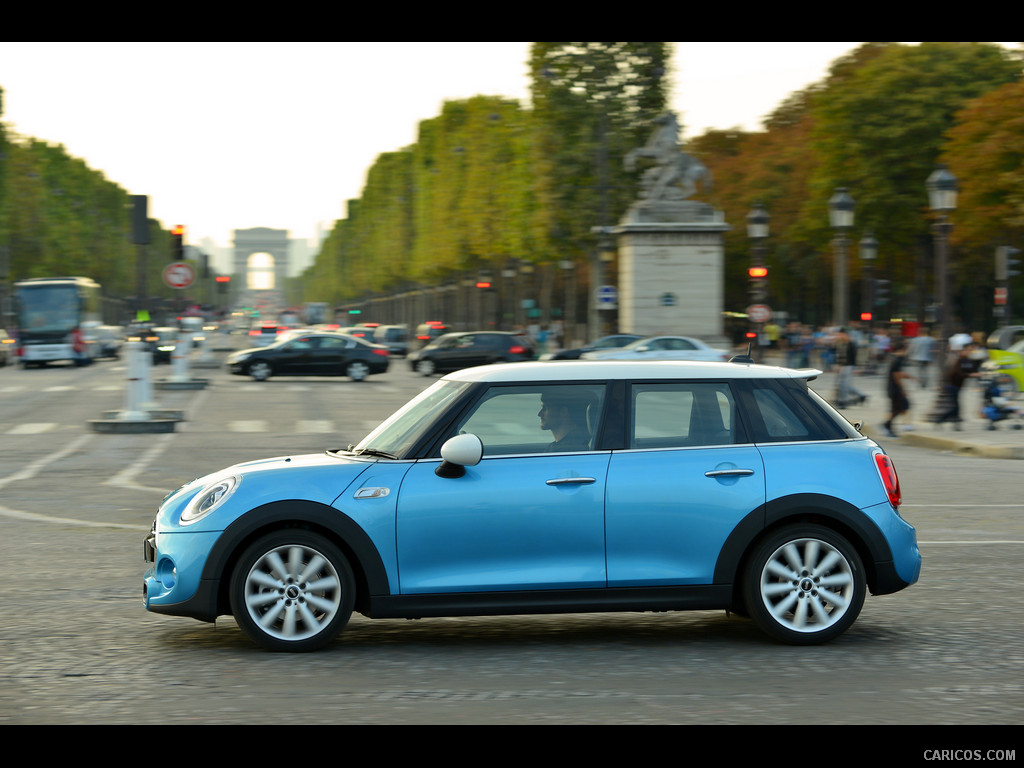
[0, 42, 1016, 270]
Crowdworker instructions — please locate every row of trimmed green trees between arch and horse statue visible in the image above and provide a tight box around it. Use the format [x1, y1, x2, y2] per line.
[302, 43, 671, 319]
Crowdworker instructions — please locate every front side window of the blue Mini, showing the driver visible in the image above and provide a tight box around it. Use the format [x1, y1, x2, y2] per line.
[456, 384, 604, 456]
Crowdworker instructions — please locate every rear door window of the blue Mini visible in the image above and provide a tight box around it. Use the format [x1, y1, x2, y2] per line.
[629, 382, 736, 449]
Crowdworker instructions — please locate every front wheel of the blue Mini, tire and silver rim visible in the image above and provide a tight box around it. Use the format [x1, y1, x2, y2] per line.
[230, 528, 355, 652]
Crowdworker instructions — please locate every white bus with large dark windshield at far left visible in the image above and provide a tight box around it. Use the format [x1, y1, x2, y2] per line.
[14, 278, 102, 367]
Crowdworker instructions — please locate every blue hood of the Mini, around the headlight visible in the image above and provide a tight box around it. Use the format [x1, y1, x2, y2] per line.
[158, 453, 377, 531]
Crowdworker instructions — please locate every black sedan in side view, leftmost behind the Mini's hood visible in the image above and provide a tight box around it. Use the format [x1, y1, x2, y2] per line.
[224, 333, 389, 381]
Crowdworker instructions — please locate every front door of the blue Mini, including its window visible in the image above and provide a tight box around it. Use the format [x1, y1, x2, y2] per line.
[396, 385, 610, 594]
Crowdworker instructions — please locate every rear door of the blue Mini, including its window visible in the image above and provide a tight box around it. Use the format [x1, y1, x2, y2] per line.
[607, 381, 765, 587]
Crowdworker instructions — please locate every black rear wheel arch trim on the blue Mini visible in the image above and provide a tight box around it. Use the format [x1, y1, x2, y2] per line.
[715, 494, 905, 605]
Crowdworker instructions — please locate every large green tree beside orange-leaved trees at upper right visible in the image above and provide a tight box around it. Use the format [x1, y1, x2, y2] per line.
[802, 42, 1020, 309]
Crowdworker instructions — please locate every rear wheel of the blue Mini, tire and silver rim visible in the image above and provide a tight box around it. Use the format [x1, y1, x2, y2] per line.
[743, 524, 867, 645]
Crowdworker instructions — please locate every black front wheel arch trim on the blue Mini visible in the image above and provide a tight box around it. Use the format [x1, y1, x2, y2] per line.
[203, 500, 390, 615]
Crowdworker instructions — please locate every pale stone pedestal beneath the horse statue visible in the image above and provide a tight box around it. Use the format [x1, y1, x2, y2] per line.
[613, 200, 729, 346]
